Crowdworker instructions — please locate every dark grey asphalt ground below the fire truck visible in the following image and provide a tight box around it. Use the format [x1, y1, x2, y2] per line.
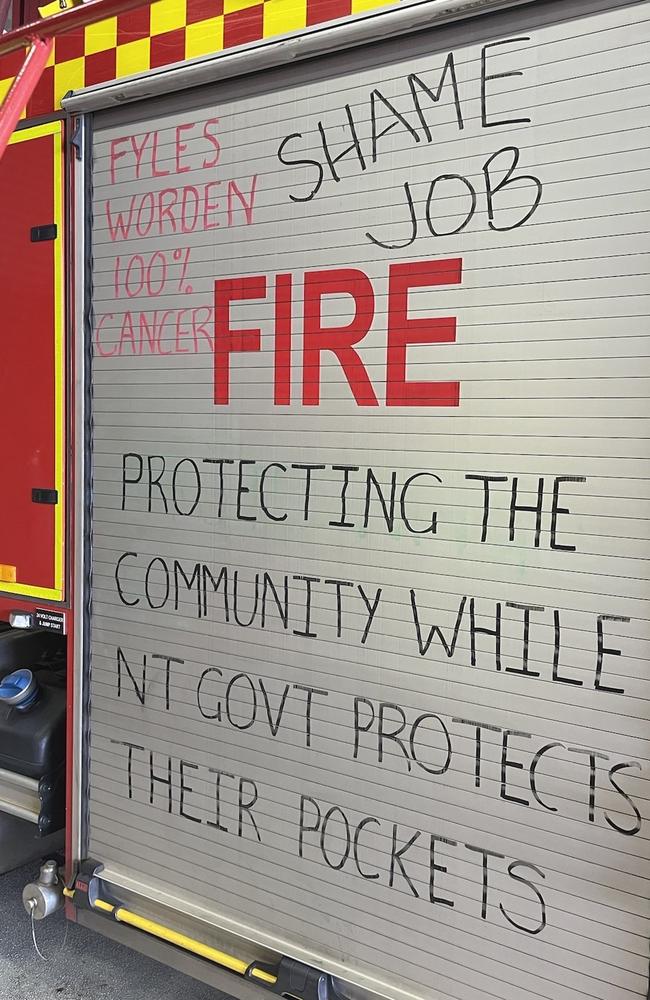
[0, 864, 227, 1000]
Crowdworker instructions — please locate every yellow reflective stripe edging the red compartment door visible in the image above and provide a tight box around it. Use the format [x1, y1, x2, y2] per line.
[2, 122, 65, 601]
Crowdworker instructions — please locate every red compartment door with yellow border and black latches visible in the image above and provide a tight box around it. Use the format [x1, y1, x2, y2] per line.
[0, 122, 65, 601]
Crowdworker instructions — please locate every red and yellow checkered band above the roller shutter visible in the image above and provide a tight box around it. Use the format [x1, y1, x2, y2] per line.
[0, 0, 397, 118]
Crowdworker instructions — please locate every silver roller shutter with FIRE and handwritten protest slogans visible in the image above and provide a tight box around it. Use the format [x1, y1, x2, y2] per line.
[83, 3, 650, 1000]
